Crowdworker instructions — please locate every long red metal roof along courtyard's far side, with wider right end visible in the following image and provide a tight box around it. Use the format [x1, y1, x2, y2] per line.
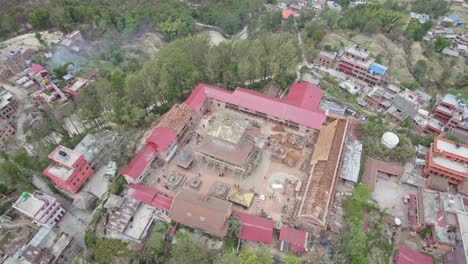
[185, 82, 326, 129]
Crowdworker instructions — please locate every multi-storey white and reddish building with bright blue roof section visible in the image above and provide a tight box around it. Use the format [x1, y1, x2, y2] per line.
[337, 45, 387, 86]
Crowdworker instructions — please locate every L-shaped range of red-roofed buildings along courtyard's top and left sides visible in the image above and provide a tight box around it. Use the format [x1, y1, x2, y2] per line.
[122, 82, 326, 183]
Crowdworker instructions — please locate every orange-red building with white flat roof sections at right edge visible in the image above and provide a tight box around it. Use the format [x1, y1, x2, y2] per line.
[422, 137, 468, 185]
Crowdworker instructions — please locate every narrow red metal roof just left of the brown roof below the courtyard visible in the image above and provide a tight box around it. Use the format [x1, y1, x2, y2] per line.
[128, 183, 172, 211]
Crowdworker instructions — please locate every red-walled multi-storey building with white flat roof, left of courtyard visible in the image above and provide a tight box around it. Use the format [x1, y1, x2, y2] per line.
[44, 146, 94, 194]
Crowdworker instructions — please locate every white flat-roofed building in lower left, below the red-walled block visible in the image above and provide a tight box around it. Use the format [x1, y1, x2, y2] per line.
[13, 192, 65, 228]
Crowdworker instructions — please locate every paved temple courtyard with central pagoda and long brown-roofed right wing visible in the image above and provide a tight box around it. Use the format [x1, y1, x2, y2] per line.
[123, 82, 348, 234]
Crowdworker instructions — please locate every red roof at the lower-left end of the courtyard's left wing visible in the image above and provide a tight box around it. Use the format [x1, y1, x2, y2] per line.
[122, 144, 158, 180]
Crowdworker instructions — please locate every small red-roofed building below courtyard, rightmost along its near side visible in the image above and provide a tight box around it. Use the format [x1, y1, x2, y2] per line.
[280, 226, 309, 253]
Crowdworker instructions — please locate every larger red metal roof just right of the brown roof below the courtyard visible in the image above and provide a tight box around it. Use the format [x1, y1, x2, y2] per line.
[234, 212, 274, 244]
